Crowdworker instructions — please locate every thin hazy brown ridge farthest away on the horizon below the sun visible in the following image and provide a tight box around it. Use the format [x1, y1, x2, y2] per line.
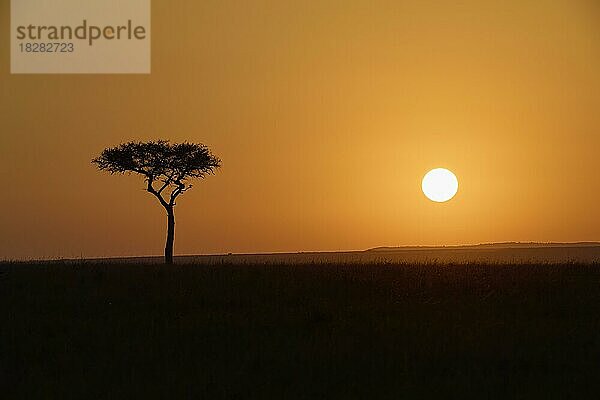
[366, 242, 600, 251]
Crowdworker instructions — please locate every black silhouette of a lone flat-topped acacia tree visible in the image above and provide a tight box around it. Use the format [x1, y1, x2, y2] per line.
[92, 140, 221, 264]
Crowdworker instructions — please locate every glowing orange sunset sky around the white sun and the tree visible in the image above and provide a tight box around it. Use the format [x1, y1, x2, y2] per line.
[0, 0, 600, 258]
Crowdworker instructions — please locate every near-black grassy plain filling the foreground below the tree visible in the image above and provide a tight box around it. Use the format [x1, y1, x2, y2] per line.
[0, 262, 600, 399]
